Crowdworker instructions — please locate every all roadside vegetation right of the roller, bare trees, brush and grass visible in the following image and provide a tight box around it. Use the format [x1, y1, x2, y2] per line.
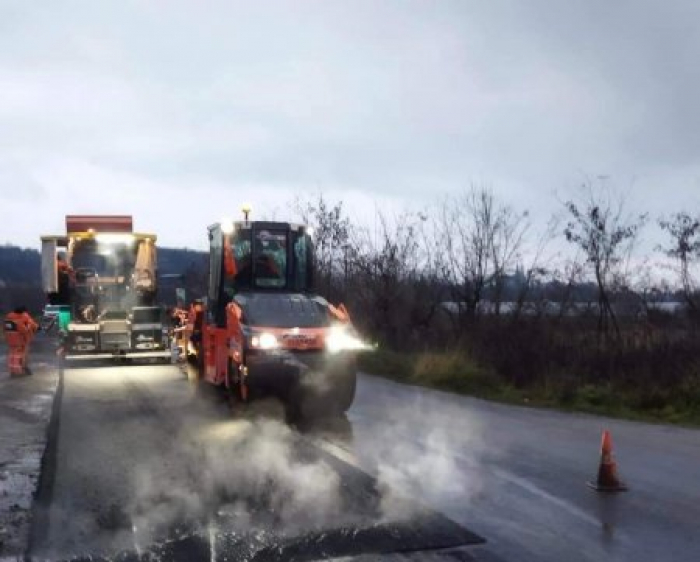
[297, 184, 700, 425]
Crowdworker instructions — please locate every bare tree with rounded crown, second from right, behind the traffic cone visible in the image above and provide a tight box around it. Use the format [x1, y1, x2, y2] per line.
[564, 184, 646, 340]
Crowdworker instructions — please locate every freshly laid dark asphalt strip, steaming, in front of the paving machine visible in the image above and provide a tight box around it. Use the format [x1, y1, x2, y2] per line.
[31, 365, 486, 561]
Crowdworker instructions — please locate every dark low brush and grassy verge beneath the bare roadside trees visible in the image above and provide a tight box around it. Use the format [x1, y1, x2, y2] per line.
[360, 331, 700, 425]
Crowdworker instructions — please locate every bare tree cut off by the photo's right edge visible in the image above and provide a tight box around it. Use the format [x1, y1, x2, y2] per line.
[659, 211, 700, 312]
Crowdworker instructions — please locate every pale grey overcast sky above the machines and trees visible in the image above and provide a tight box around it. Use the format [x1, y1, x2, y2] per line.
[0, 0, 700, 248]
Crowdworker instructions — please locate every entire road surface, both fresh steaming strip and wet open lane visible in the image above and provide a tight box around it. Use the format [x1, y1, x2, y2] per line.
[27, 358, 700, 562]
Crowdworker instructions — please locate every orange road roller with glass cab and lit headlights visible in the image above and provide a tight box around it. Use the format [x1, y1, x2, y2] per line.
[183, 211, 363, 416]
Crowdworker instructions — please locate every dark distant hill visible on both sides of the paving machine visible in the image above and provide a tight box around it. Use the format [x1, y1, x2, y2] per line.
[0, 244, 208, 313]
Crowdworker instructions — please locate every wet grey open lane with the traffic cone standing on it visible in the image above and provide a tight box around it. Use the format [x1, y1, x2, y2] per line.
[349, 376, 700, 562]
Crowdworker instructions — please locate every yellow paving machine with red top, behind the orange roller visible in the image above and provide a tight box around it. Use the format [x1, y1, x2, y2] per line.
[41, 215, 170, 360]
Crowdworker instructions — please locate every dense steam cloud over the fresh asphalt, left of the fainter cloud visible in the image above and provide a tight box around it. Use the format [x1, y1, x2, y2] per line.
[130, 396, 353, 544]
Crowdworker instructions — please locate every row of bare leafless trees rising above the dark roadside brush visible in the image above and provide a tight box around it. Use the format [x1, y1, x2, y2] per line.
[296, 184, 700, 347]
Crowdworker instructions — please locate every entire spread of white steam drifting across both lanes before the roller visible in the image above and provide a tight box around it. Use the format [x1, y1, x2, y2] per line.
[37, 370, 481, 557]
